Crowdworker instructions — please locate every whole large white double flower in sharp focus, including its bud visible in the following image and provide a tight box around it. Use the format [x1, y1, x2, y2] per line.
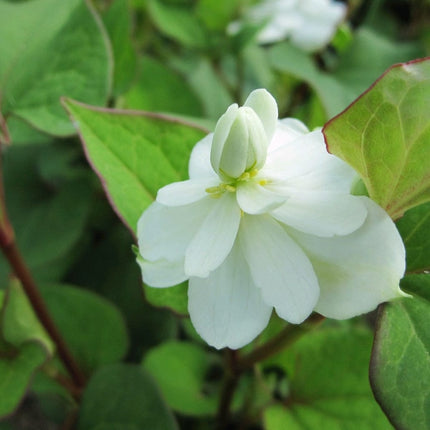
[138, 89, 405, 348]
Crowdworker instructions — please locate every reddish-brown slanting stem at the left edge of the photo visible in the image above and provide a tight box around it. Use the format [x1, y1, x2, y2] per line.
[0, 147, 85, 390]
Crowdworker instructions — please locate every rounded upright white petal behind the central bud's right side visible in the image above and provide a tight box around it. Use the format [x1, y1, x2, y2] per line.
[244, 88, 278, 141]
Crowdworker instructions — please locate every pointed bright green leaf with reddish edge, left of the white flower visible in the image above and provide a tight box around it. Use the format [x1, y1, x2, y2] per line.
[61, 100, 206, 235]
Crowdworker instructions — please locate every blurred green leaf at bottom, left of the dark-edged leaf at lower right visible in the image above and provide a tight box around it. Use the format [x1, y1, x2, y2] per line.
[264, 327, 391, 430]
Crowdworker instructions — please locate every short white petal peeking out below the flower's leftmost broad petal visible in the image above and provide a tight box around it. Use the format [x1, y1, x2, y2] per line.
[137, 258, 188, 288]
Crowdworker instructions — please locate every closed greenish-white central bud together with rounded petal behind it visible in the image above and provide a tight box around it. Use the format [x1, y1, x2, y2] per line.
[211, 90, 277, 181]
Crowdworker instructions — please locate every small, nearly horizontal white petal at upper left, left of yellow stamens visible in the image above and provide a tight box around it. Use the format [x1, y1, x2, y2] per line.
[157, 177, 219, 206]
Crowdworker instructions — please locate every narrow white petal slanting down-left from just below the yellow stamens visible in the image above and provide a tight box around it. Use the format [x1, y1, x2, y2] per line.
[185, 192, 241, 278]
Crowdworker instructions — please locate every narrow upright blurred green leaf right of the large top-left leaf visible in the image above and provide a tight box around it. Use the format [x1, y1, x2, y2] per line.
[103, 0, 137, 96]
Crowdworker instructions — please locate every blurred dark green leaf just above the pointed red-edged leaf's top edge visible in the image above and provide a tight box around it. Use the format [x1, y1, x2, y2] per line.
[121, 57, 202, 116]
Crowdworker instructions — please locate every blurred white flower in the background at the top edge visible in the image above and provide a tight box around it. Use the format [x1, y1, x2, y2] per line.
[230, 0, 347, 52]
